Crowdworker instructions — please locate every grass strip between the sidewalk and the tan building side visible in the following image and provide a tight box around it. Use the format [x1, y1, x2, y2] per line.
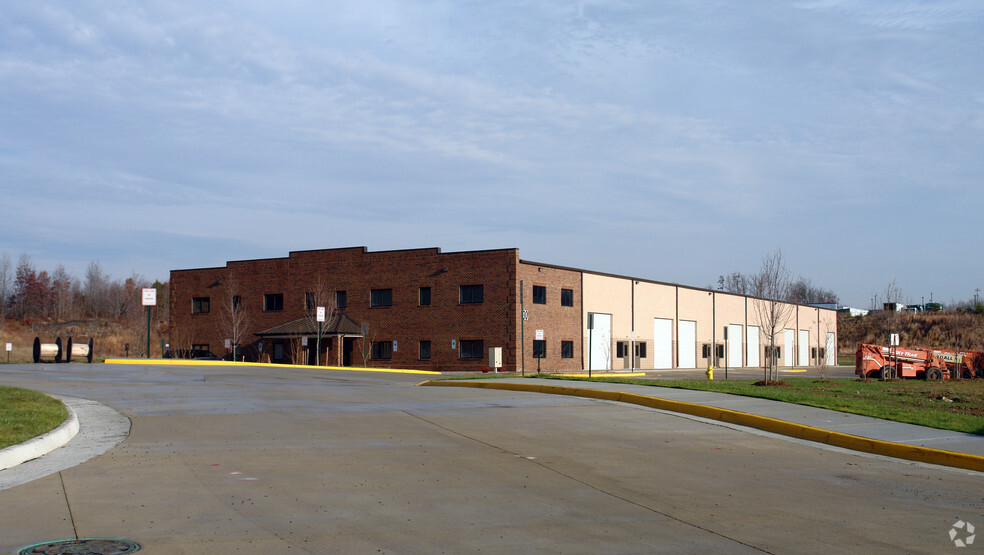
[540, 374, 984, 435]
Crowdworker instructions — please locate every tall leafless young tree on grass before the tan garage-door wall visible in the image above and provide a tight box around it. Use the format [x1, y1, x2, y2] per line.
[752, 249, 793, 381]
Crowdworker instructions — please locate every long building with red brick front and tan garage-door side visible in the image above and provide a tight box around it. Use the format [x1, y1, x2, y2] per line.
[169, 247, 836, 371]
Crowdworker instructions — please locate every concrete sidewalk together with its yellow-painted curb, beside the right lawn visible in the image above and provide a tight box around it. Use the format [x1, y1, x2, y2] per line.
[425, 378, 984, 472]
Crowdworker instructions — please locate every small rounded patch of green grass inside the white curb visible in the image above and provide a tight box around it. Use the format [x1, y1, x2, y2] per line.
[0, 386, 68, 449]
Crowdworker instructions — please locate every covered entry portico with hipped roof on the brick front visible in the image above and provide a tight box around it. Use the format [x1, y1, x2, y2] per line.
[255, 314, 362, 366]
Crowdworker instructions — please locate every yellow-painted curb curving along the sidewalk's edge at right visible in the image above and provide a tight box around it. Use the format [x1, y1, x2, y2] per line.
[419, 380, 984, 472]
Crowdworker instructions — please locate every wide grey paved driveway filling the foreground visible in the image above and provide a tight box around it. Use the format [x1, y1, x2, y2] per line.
[0, 364, 984, 553]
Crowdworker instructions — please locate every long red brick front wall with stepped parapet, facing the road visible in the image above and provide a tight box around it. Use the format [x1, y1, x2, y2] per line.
[171, 247, 524, 371]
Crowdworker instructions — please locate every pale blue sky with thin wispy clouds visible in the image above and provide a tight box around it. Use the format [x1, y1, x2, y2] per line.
[0, 0, 984, 308]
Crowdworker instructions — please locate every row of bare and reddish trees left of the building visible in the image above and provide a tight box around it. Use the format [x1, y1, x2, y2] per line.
[0, 252, 167, 322]
